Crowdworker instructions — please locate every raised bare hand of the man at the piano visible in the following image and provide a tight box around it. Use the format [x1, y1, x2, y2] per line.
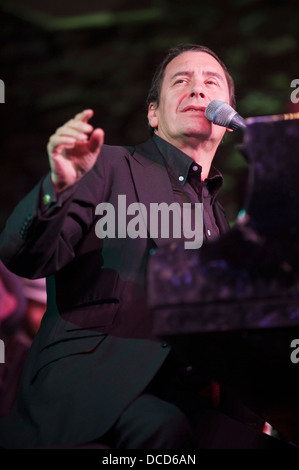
[47, 109, 104, 192]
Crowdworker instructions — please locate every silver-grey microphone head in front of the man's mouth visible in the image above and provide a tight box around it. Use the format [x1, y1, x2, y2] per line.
[205, 100, 246, 132]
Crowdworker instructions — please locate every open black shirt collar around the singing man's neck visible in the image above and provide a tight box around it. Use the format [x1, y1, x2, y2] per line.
[153, 134, 223, 199]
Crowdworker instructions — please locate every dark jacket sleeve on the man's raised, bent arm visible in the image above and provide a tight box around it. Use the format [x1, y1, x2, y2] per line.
[0, 154, 105, 278]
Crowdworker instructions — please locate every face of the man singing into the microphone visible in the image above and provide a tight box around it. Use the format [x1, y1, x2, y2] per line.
[148, 51, 229, 145]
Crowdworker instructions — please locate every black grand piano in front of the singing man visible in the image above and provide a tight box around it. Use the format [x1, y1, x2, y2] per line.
[148, 113, 299, 446]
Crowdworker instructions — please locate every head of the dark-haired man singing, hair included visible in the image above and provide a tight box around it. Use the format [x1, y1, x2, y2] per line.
[147, 44, 236, 146]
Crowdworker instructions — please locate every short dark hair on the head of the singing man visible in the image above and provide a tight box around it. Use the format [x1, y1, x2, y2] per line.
[146, 44, 236, 132]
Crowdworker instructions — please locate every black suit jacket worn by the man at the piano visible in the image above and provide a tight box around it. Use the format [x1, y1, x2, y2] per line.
[0, 139, 228, 447]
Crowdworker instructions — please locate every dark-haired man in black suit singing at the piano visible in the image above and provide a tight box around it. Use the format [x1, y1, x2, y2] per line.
[0, 45, 274, 449]
